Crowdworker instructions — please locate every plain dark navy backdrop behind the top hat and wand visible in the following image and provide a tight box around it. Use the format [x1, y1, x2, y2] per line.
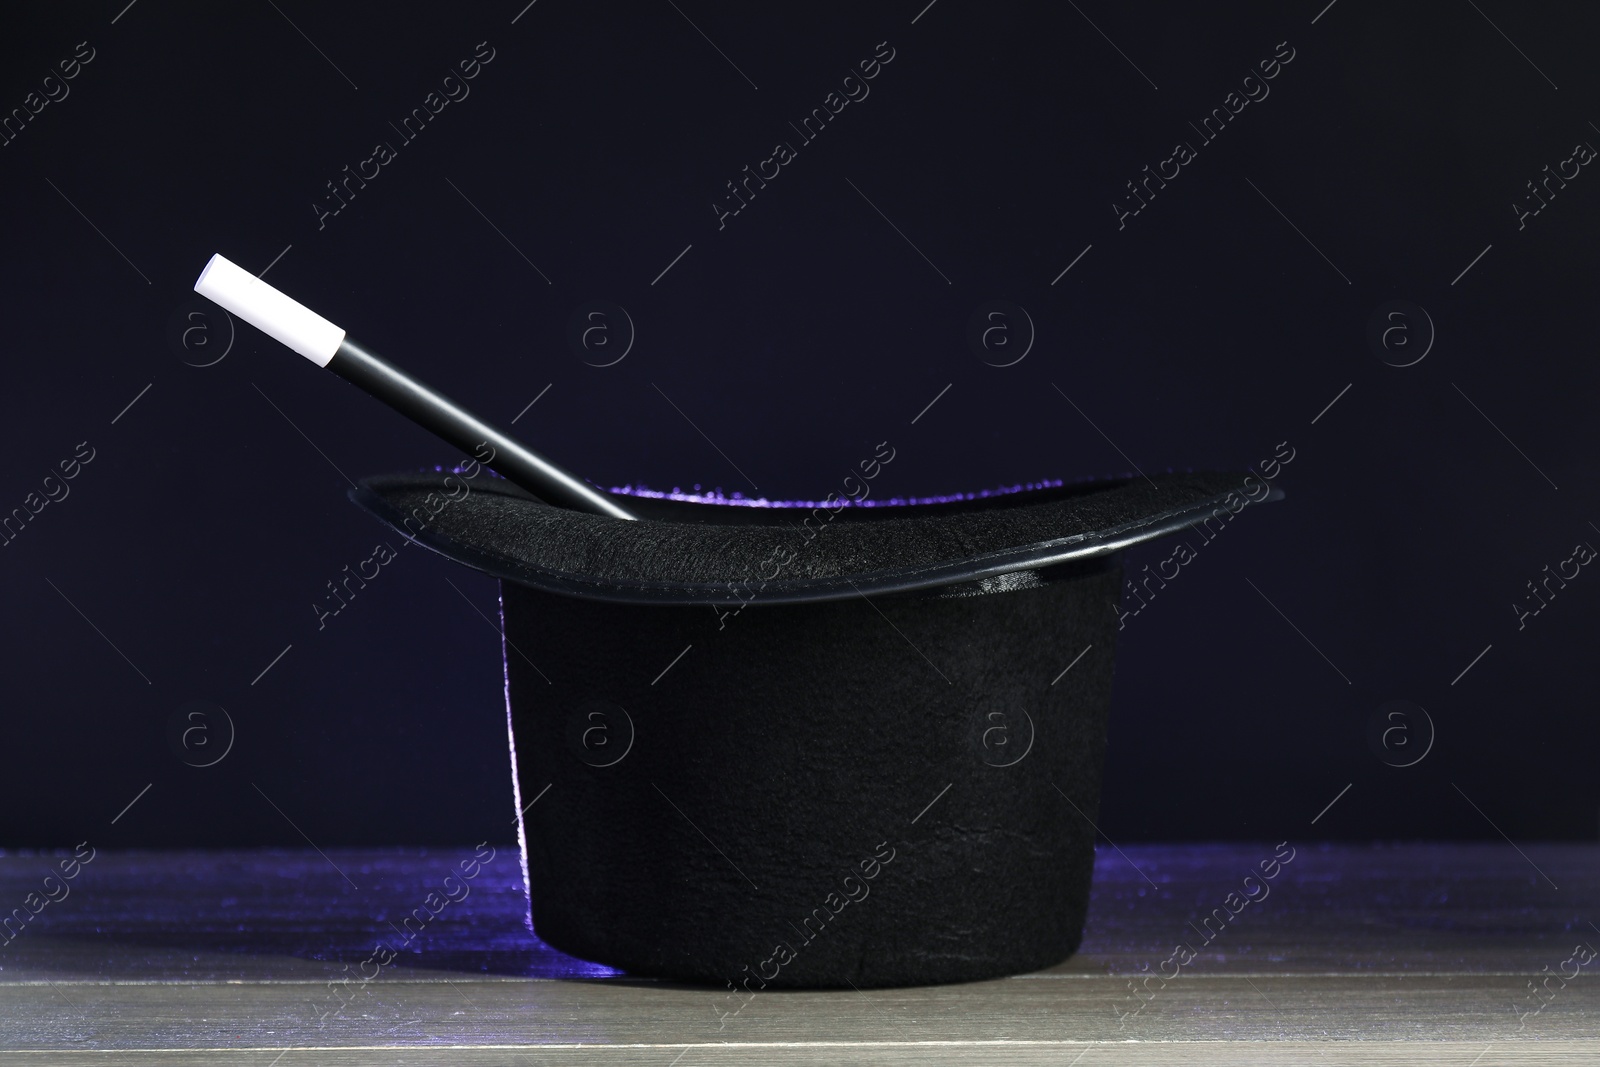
[0, 0, 1600, 846]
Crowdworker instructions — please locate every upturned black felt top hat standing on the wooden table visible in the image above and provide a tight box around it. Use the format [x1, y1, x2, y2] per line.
[352, 470, 1275, 991]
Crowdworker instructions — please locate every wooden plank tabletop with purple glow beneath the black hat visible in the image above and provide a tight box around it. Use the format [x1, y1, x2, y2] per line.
[0, 845, 1600, 1067]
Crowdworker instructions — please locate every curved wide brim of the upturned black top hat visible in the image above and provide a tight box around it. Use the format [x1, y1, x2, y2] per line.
[350, 470, 1282, 605]
